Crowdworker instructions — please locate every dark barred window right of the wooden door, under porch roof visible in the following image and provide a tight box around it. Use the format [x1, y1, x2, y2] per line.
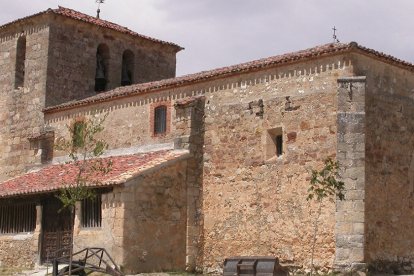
[82, 194, 102, 228]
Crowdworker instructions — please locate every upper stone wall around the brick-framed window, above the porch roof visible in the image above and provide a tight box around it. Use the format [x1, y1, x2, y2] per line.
[45, 89, 202, 157]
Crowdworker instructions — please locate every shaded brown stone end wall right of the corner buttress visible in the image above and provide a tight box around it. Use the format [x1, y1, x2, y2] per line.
[354, 52, 414, 274]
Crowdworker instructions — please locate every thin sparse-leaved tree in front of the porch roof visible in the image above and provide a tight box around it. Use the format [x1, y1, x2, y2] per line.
[56, 115, 112, 275]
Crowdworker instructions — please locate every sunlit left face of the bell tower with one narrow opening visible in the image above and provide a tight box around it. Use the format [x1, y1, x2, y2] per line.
[0, 17, 49, 181]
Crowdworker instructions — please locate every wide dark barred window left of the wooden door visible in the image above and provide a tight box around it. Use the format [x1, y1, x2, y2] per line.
[0, 203, 36, 234]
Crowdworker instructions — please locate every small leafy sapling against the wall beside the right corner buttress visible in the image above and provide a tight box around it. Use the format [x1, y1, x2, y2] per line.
[306, 158, 345, 276]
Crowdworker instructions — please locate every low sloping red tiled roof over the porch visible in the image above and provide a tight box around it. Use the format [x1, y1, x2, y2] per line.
[0, 150, 189, 198]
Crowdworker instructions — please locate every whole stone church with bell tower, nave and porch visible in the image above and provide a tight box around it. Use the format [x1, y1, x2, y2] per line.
[0, 7, 414, 273]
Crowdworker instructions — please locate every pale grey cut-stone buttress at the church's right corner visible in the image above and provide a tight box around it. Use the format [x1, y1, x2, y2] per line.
[335, 77, 366, 271]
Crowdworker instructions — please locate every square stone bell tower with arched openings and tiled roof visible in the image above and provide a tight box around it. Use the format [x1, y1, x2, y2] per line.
[0, 7, 183, 181]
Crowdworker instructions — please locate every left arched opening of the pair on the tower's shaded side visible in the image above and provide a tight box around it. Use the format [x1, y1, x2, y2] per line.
[95, 44, 109, 92]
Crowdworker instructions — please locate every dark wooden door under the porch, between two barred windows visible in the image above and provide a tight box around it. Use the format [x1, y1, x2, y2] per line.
[41, 197, 73, 263]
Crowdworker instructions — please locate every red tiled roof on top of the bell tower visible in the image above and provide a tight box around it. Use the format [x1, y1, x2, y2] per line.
[0, 6, 184, 51]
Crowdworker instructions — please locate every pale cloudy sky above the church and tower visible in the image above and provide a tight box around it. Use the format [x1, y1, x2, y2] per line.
[0, 0, 414, 75]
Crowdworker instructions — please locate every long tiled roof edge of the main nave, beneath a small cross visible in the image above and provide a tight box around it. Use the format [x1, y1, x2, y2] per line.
[43, 42, 414, 113]
